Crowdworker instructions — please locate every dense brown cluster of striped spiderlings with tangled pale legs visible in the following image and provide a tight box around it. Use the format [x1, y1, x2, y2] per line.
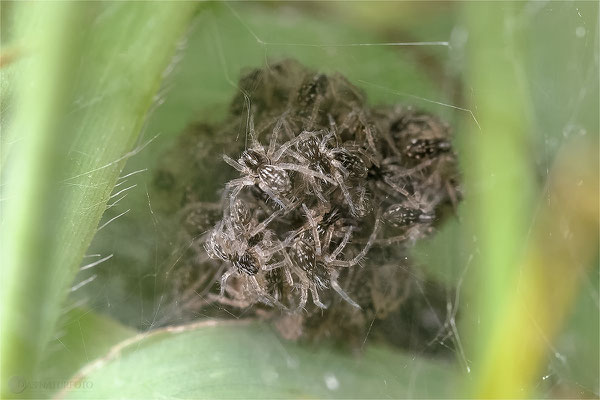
[184, 60, 460, 313]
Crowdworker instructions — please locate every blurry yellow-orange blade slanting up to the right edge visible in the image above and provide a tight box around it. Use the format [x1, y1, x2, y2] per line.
[476, 140, 598, 398]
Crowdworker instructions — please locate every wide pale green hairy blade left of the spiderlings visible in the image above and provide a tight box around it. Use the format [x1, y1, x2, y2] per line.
[0, 2, 195, 397]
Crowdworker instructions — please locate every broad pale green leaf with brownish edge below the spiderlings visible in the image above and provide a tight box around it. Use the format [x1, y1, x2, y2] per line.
[62, 320, 456, 398]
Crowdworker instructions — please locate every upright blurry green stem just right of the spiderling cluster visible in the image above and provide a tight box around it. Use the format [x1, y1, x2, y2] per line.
[462, 3, 534, 397]
